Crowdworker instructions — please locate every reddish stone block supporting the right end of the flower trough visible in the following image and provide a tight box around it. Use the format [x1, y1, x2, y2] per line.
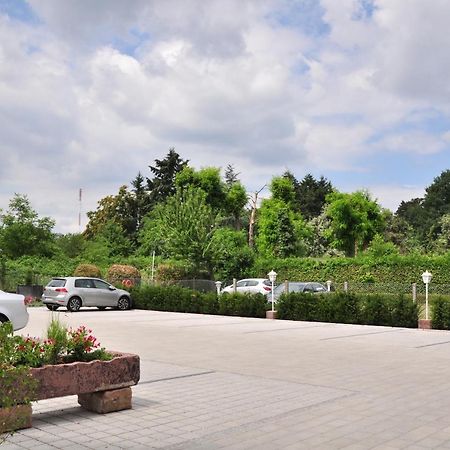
[78, 387, 131, 414]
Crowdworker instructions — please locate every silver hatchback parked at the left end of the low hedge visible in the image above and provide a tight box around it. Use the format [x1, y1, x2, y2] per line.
[42, 277, 132, 312]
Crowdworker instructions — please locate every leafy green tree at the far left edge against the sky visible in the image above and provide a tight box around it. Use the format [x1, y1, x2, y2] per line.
[0, 194, 55, 258]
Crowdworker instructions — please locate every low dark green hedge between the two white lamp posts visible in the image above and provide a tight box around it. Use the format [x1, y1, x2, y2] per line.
[277, 292, 419, 328]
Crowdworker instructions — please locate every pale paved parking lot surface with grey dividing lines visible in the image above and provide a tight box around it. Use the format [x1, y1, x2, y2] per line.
[1, 308, 450, 450]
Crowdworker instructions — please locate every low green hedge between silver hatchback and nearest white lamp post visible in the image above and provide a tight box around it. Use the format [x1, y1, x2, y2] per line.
[131, 286, 268, 317]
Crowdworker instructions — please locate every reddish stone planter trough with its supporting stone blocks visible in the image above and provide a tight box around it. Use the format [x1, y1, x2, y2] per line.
[0, 352, 140, 433]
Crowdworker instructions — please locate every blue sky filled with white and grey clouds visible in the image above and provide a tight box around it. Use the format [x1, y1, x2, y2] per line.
[0, 0, 450, 233]
